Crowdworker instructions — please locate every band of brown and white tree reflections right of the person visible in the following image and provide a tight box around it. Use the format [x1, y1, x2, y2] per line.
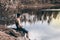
[23, 11, 59, 24]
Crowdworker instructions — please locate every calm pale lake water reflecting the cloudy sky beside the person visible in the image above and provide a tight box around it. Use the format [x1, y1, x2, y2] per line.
[8, 12, 60, 40]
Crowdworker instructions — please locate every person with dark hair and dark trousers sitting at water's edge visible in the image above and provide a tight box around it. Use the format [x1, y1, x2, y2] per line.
[16, 13, 29, 38]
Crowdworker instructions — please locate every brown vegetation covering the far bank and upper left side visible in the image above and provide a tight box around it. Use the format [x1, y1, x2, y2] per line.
[0, 0, 60, 25]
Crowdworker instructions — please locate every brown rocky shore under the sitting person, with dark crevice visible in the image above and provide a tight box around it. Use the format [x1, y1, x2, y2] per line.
[0, 26, 29, 40]
